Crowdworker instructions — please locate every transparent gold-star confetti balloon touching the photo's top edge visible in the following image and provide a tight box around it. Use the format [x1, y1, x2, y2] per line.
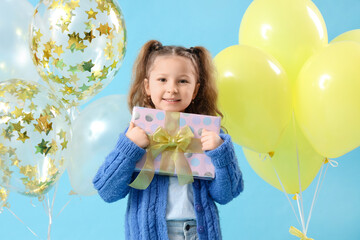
[30, 0, 126, 108]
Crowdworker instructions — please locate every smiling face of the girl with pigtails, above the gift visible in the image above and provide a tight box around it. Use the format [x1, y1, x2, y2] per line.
[144, 55, 200, 112]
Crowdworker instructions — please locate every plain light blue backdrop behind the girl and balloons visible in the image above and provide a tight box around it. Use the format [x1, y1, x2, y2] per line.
[0, 0, 360, 240]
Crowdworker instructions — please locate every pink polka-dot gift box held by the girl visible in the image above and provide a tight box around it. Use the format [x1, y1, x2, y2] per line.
[131, 107, 220, 189]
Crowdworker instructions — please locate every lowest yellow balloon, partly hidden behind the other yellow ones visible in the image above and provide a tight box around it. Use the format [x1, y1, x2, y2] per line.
[243, 117, 324, 194]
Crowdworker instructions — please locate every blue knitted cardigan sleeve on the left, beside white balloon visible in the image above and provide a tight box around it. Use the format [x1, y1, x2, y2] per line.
[93, 131, 146, 202]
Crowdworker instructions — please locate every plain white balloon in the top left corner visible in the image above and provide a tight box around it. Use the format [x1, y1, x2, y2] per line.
[0, 0, 40, 82]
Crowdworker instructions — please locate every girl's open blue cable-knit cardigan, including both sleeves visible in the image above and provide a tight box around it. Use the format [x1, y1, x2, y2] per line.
[93, 133, 244, 240]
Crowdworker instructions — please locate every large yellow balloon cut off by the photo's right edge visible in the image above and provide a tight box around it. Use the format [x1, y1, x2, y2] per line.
[295, 41, 360, 158]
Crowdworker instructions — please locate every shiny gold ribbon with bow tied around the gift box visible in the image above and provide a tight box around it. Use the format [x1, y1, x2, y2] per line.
[129, 112, 203, 190]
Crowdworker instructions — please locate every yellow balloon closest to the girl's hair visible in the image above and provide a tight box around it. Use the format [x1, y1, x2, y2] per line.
[214, 45, 291, 153]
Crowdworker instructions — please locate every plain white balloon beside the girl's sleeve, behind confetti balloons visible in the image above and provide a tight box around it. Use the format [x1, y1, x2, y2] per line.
[67, 95, 131, 196]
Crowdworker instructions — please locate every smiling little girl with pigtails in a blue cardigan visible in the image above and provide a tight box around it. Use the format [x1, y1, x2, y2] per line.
[93, 40, 243, 240]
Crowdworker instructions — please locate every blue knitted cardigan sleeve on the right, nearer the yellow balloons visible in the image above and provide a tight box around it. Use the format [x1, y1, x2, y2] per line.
[205, 133, 244, 204]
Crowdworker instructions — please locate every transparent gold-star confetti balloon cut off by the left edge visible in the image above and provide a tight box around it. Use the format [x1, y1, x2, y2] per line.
[0, 79, 71, 196]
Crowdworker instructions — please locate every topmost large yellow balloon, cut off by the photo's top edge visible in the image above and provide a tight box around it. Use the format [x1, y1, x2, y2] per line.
[239, 0, 328, 85]
